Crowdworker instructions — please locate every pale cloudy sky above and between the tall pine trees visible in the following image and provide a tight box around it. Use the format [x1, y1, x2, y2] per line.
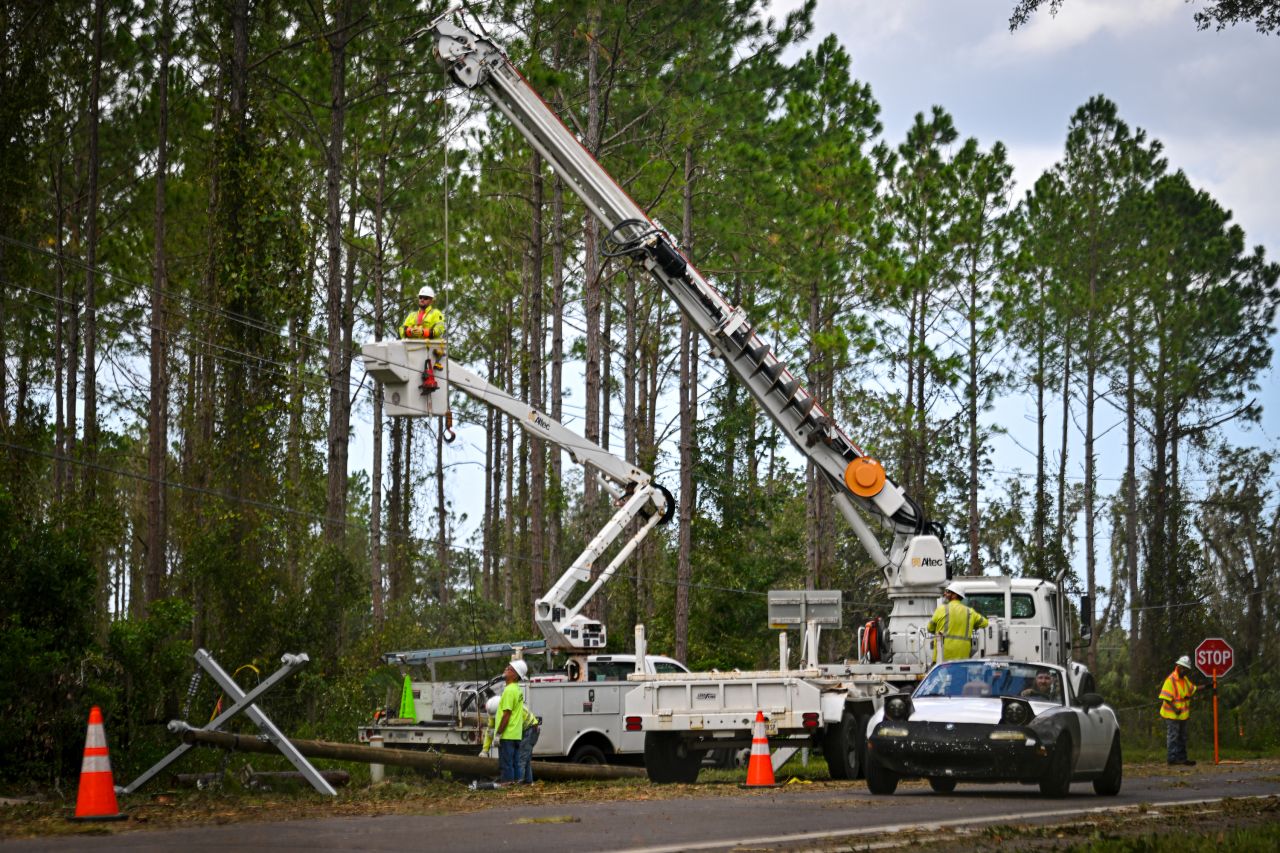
[352, 0, 1280, 612]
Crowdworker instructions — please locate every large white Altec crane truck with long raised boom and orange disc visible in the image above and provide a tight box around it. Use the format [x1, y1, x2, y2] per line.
[424, 13, 1090, 781]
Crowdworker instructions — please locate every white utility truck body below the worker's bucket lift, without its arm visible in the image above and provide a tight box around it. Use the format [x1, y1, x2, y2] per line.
[358, 642, 689, 765]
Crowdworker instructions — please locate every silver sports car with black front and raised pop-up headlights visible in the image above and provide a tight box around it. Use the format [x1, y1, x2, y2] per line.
[867, 658, 1123, 797]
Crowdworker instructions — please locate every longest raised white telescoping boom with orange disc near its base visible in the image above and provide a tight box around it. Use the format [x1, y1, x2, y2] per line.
[425, 13, 945, 587]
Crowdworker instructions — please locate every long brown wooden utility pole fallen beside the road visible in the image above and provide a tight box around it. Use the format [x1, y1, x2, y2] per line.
[169, 721, 645, 781]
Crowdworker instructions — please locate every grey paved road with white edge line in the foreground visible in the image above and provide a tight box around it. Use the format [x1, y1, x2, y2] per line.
[12, 765, 1280, 853]
